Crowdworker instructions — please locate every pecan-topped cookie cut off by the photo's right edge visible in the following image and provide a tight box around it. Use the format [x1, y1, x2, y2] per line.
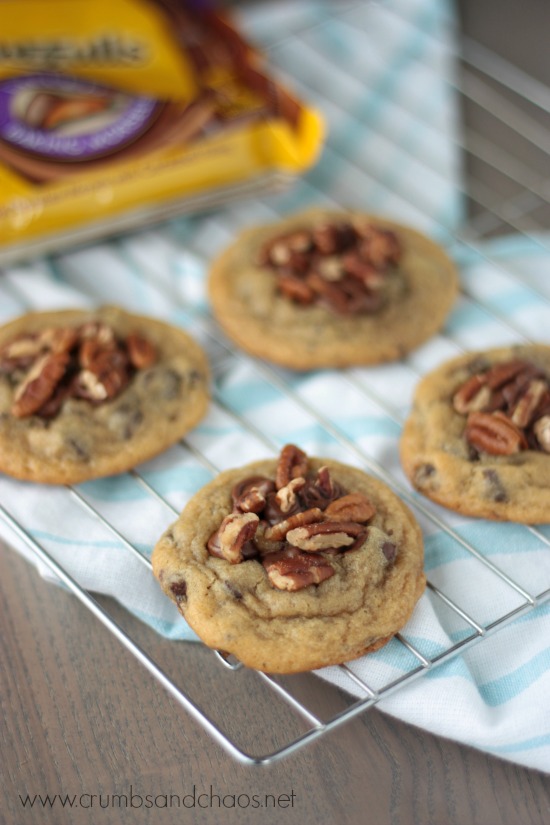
[400, 344, 550, 524]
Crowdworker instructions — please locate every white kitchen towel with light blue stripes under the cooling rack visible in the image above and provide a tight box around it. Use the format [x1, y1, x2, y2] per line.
[0, 0, 550, 771]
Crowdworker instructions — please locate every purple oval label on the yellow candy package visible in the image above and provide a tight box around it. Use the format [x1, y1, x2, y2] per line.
[0, 74, 159, 161]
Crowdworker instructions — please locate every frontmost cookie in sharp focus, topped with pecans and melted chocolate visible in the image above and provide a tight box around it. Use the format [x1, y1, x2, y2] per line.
[152, 444, 425, 673]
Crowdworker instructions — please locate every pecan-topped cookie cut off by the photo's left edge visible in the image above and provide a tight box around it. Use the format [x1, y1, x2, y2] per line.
[0, 306, 209, 484]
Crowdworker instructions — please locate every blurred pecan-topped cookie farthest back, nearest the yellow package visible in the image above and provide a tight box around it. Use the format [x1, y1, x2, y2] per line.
[209, 209, 458, 370]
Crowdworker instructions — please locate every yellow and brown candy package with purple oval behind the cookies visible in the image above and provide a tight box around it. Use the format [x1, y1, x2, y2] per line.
[0, 0, 323, 263]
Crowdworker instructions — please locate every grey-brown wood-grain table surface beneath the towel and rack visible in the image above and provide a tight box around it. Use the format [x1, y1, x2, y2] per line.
[0, 0, 550, 825]
